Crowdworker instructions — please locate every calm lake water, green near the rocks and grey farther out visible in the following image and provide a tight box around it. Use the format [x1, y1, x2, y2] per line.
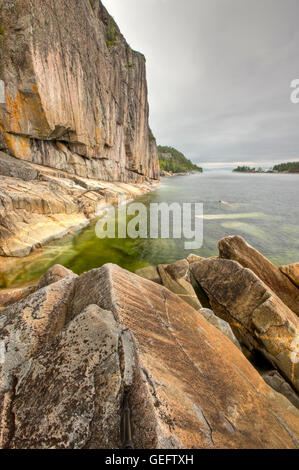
[1, 171, 299, 287]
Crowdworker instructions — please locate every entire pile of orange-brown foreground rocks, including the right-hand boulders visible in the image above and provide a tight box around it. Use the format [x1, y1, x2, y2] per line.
[0, 237, 299, 449]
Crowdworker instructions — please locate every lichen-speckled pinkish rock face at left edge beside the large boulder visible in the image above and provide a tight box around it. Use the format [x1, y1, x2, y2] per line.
[0, 276, 74, 393]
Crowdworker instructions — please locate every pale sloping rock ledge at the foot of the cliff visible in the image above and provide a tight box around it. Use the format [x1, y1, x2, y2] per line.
[0, 152, 158, 260]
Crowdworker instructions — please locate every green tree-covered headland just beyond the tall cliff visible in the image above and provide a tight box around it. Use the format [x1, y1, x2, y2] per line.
[158, 145, 203, 176]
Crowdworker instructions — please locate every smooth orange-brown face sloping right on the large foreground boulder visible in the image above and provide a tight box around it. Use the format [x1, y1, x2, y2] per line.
[69, 265, 299, 448]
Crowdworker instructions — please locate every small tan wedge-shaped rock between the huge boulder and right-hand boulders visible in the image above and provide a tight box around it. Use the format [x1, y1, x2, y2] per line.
[158, 259, 202, 310]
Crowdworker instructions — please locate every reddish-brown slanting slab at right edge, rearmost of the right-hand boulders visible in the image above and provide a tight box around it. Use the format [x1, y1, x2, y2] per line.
[218, 236, 299, 315]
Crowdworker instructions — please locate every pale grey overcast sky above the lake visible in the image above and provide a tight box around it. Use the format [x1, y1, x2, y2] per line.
[103, 0, 299, 164]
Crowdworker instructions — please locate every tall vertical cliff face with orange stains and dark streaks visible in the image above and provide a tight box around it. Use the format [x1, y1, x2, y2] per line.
[0, 0, 159, 182]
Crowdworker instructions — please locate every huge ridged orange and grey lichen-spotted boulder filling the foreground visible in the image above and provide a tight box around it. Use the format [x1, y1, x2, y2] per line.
[0, 265, 299, 449]
